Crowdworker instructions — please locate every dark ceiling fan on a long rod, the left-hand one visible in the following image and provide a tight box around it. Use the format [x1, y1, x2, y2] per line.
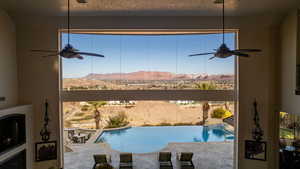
[31, 0, 104, 59]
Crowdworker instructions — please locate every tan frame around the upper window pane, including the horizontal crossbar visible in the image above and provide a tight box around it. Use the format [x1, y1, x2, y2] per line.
[58, 29, 238, 102]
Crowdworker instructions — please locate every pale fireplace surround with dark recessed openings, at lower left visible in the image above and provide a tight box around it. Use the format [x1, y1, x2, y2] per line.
[0, 105, 33, 169]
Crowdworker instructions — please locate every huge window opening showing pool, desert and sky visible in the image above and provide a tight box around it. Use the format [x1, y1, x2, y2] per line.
[60, 30, 237, 169]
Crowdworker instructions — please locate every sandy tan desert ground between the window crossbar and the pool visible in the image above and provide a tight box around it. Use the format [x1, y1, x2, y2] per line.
[64, 101, 233, 128]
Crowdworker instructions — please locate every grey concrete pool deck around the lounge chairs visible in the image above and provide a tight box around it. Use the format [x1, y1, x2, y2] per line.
[64, 141, 234, 169]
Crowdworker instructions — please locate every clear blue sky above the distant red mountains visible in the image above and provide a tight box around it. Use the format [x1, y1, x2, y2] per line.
[62, 33, 235, 78]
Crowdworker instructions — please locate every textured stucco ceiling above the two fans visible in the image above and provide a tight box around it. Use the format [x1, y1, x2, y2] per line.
[0, 0, 300, 16]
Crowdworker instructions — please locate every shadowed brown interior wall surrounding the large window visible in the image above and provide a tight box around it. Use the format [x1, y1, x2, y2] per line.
[17, 16, 278, 169]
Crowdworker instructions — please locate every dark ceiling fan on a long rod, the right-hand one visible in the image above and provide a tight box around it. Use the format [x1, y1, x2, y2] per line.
[189, 0, 262, 60]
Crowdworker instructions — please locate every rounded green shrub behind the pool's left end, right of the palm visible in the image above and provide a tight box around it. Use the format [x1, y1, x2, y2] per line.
[105, 112, 129, 128]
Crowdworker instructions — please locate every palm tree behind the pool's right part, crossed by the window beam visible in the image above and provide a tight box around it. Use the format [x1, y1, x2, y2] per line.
[195, 82, 217, 125]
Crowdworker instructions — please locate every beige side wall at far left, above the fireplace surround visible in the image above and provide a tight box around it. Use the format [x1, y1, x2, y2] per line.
[0, 9, 18, 109]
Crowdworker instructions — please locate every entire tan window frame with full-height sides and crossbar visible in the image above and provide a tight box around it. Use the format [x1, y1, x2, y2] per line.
[58, 29, 239, 169]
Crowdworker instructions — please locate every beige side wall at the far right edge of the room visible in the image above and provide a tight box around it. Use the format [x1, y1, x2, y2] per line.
[281, 10, 300, 114]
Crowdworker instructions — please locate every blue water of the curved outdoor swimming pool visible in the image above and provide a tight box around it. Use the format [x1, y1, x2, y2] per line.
[96, 125, 234, 153]
